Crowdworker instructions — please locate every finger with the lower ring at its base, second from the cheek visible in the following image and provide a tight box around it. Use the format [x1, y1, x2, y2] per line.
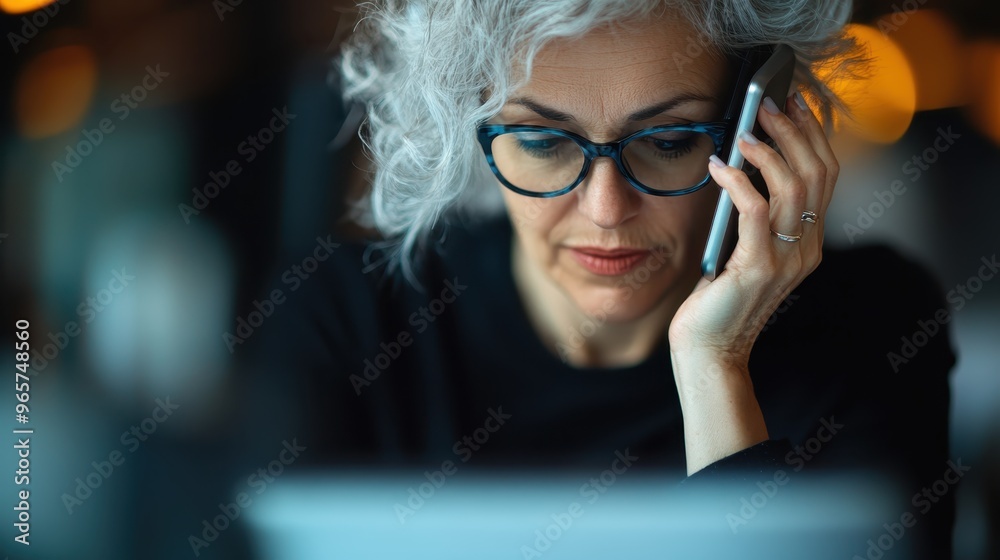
[737, 133, 806, 245]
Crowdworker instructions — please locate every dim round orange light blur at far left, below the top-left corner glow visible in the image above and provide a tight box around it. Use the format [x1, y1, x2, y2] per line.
[14, 45, 97, 138]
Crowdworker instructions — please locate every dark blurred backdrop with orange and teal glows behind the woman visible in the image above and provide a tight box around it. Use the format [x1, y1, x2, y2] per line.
[0, 0, 1000, 559]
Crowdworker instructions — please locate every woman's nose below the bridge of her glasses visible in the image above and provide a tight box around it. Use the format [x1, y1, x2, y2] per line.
[576, 157, 642, 229]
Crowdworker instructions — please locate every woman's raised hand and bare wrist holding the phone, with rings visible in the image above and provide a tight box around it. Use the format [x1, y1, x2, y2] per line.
[668, 94, 839, 474]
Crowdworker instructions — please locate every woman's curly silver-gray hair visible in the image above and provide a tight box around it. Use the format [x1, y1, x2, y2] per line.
[335, 0, 861, 275]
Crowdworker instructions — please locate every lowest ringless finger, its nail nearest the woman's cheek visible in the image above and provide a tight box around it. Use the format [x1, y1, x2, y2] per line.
[708, 155, 771, 255]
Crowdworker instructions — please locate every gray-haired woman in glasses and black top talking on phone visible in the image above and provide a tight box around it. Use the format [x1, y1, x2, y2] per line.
[248, 0, 954, 558]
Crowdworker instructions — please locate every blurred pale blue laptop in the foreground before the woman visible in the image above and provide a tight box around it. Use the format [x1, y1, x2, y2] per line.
[244, 470, 908, 560]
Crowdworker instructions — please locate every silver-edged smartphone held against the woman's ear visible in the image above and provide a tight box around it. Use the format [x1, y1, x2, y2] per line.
[701, 45, 795, 280]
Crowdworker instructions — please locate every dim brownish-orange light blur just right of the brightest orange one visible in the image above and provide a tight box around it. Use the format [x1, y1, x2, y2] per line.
[877, 10, 969, 111]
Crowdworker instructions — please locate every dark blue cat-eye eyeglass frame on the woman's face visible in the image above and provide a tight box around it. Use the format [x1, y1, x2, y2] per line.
[476, 120, 732, 198]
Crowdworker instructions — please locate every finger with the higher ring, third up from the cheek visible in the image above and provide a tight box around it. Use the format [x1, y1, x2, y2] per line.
[757, 97, 827, 218]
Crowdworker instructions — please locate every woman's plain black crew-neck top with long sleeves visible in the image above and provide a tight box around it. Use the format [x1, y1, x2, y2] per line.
[244, 212, 955, 558]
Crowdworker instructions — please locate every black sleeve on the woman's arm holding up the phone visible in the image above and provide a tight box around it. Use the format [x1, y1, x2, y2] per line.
[681, 248, 956, 559]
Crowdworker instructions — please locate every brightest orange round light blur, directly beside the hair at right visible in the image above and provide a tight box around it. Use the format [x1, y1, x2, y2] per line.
[817, 24, 917, 144]
